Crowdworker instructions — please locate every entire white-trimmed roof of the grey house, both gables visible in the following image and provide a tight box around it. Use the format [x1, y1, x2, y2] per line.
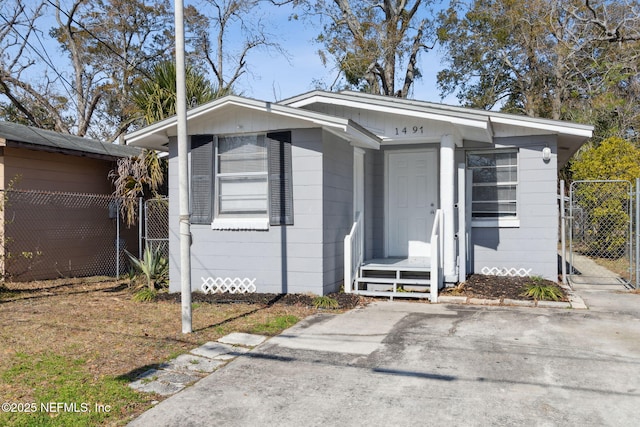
[125, 91, 593, 166]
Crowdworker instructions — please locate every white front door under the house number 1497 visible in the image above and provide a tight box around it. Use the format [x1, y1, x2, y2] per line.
[387, 149, 438, 257]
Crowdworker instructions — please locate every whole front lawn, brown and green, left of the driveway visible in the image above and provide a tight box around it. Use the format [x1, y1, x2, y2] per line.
[0, 278, 315, 426]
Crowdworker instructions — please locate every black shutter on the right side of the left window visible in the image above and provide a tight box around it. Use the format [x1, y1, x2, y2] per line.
[267, 132, 293, 225]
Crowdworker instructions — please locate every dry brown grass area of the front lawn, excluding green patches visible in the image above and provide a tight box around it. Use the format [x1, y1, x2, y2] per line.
[0, 278, 360, 424]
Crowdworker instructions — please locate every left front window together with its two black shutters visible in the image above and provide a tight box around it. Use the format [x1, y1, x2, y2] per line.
[191, 131, 293, 229]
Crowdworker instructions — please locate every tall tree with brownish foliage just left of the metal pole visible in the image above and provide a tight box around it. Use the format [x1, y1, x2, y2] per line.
[52, 0, 173, 139]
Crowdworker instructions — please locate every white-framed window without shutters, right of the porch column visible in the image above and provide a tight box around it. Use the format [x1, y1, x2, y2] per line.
[465, 148, 521, 228]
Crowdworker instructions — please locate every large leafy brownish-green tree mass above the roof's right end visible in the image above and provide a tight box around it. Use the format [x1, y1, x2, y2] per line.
[438, 0, 640, 138]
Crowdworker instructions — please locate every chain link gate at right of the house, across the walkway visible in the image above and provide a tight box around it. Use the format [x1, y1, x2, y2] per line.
[567, 180, 636, 285]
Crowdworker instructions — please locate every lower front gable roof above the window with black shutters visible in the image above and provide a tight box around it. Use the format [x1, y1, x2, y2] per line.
[125, 95, 380, 151]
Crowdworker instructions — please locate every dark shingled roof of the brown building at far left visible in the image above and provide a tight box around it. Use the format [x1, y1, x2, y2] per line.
[0, 121, 140, 160]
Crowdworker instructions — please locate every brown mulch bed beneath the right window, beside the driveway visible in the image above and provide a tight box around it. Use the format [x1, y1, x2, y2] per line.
[440, 274, 569, 301]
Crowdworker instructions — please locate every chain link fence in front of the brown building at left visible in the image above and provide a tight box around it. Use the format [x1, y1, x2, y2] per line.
[0, 190, 138, 281]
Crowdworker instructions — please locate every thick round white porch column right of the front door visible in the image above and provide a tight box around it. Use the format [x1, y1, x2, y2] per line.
[440, 135, 462, 283]
